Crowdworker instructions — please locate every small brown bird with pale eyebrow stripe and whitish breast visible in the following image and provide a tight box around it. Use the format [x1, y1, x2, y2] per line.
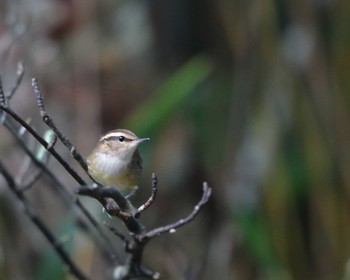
[87, 129, 150, 194]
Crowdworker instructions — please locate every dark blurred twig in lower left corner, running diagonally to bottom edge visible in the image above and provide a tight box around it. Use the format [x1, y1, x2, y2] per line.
[0, 162, 89, 280]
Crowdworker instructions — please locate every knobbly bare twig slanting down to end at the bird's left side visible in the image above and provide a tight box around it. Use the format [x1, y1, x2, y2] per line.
[32, 78, 88, 172]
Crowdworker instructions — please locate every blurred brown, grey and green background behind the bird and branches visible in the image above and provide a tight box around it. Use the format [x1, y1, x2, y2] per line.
[0, 0, 350, 280]
